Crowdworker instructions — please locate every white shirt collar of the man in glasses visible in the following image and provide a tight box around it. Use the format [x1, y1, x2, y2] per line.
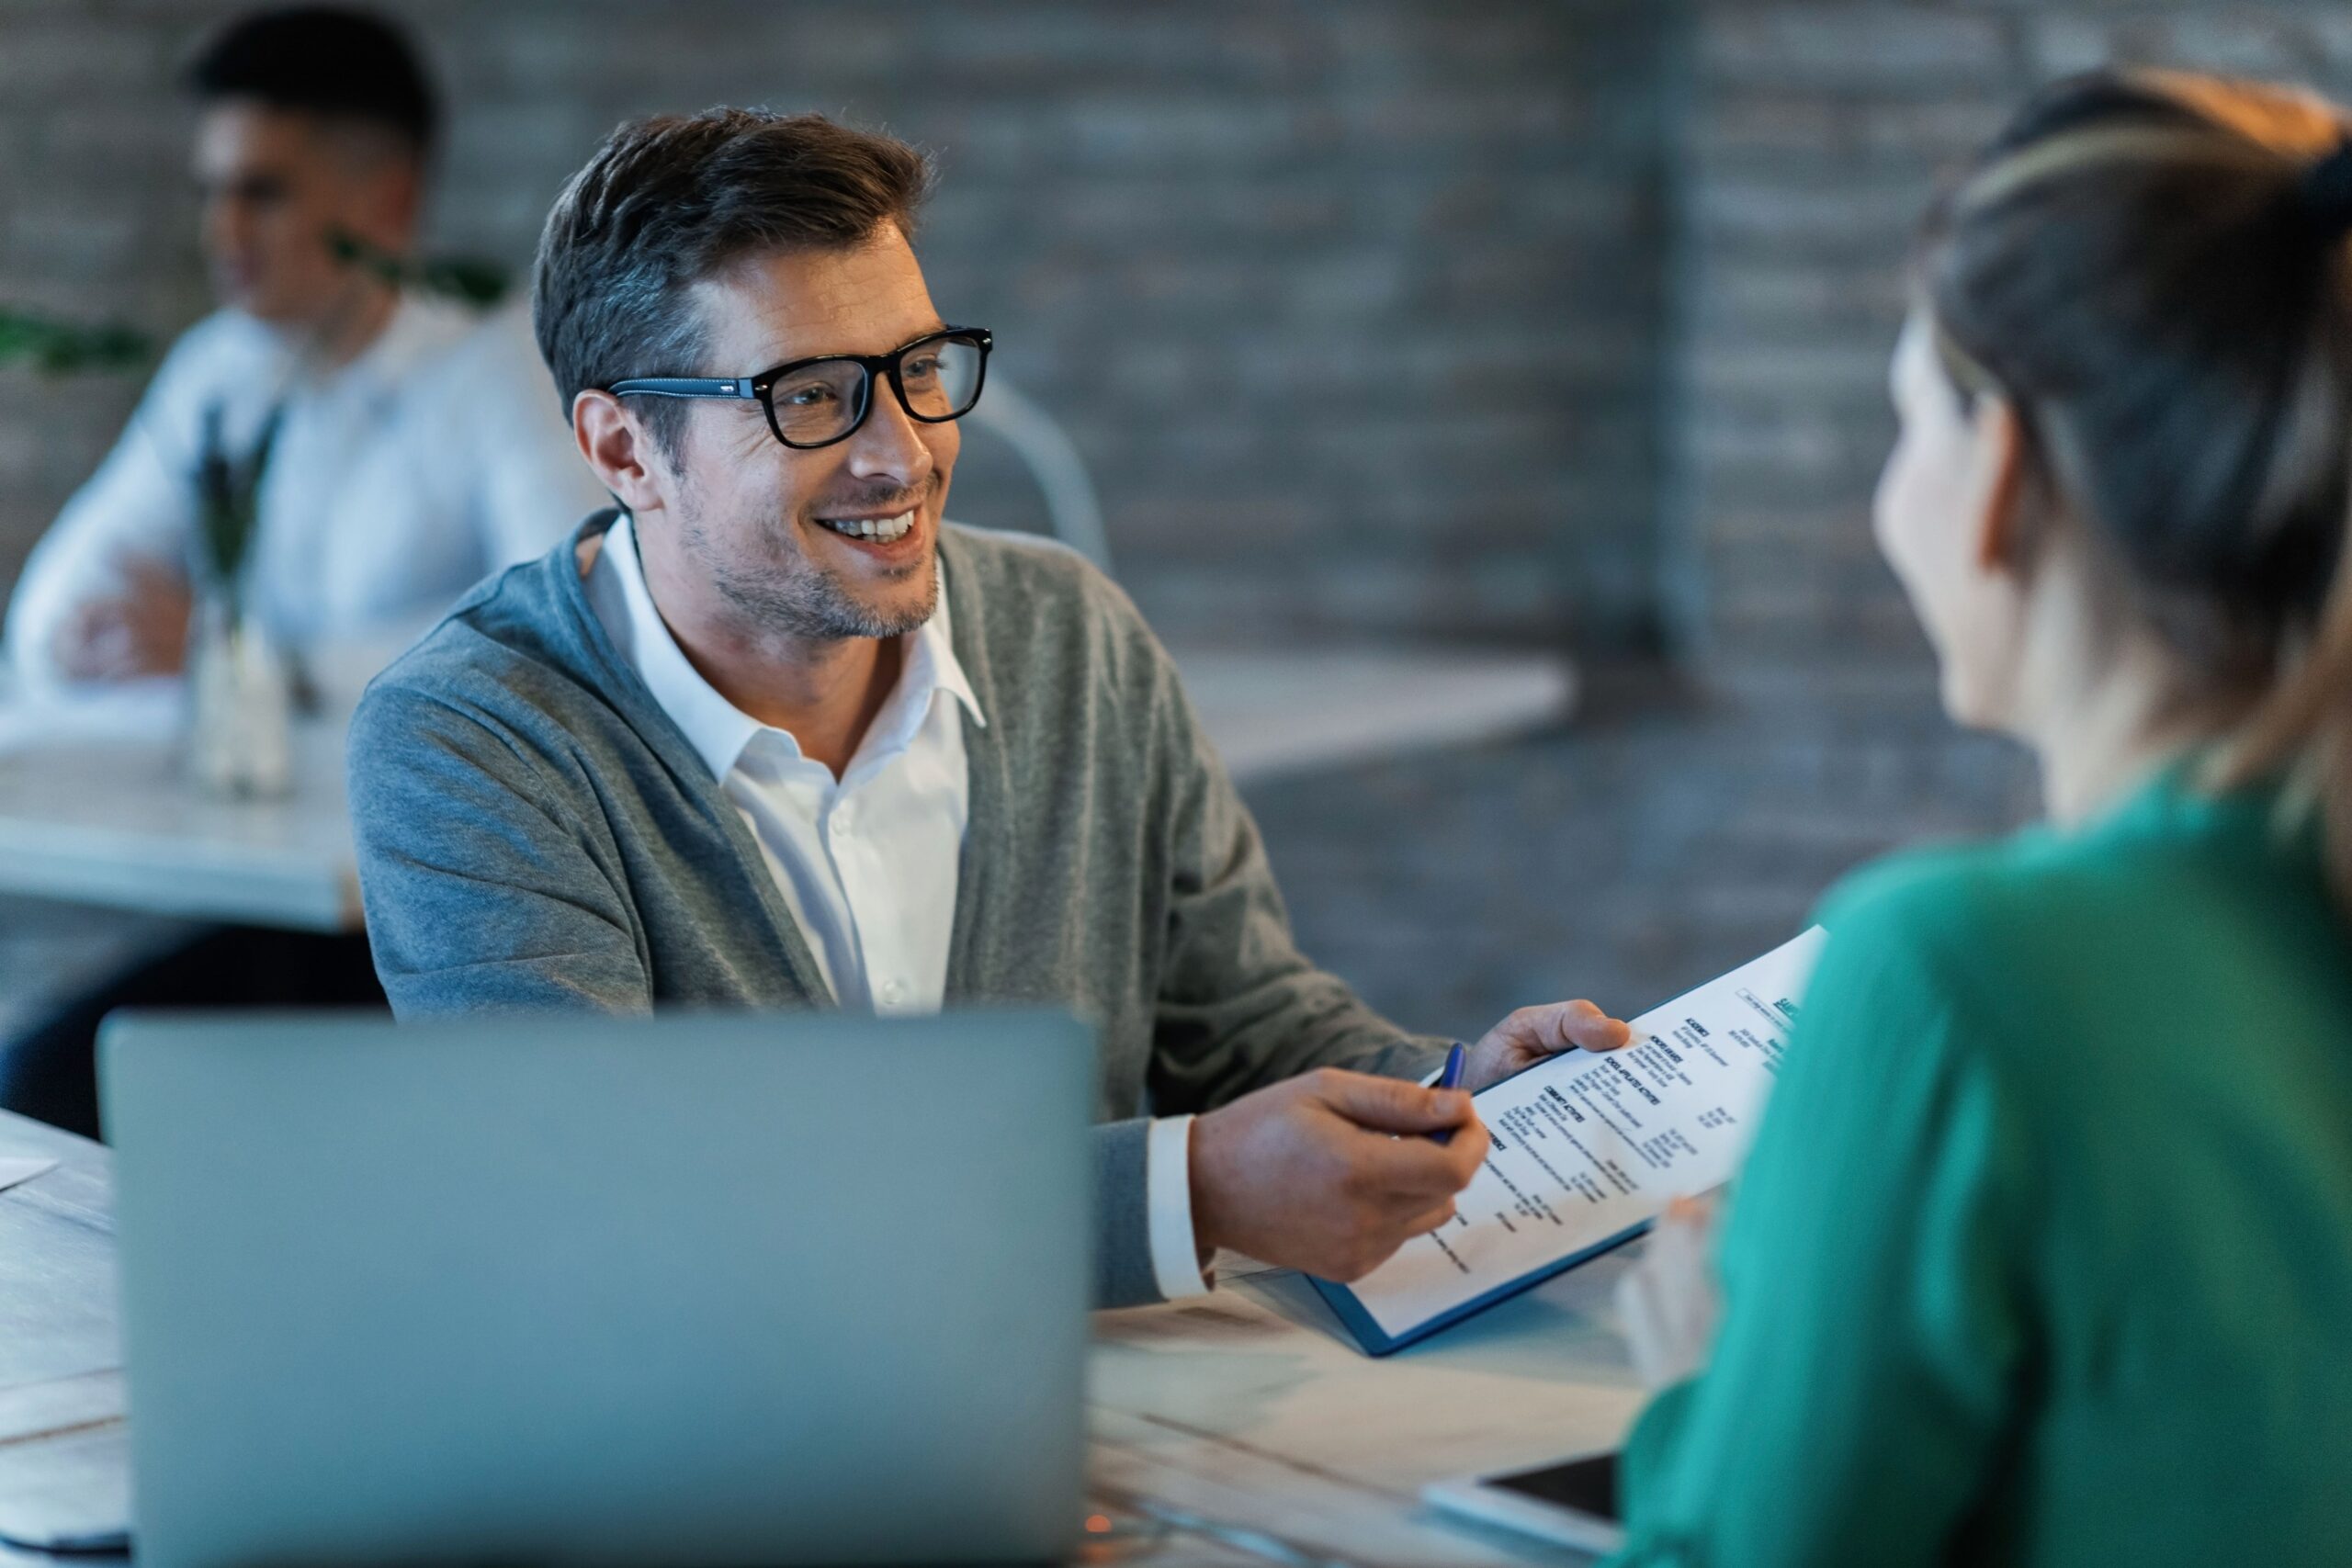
[593, 513, 988, 778]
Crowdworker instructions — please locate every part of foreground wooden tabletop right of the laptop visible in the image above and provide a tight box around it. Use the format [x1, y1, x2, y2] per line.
[1087, 1248, 1642, 1568]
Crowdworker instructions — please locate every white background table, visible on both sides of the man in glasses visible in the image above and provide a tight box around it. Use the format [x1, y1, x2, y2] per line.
[0, 649, 1576, 931]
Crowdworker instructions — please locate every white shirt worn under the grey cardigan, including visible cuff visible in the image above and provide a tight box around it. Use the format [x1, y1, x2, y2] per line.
[585, 514, 1206, 1298]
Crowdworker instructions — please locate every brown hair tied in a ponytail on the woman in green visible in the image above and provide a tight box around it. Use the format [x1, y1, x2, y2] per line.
[1919, 73, 2352, 905]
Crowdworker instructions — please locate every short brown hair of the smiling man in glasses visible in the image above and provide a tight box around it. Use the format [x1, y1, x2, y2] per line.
[532, 108, 932, 456]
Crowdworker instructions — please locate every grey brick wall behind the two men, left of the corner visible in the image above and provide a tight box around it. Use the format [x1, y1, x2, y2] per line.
[0, 0, 1665, 642]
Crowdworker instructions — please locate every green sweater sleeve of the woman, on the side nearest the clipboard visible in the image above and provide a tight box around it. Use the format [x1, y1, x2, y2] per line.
[1618, 888, 2032, 1568]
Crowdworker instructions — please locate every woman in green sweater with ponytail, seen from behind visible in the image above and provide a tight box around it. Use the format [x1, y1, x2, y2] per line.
[1618, 75, 2352, 1568]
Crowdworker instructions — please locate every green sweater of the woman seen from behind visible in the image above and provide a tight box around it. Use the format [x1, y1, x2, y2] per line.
[1623, 776, 2352, 1568]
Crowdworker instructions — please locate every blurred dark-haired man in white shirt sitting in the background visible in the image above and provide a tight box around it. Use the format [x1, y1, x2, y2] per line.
[7, 7, 600, 701]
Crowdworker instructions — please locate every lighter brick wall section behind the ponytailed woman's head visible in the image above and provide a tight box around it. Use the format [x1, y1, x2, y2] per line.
[1668, 0, 2352, 715]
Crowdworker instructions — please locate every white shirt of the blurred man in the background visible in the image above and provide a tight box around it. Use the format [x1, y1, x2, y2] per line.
[7, 296, 606, 694]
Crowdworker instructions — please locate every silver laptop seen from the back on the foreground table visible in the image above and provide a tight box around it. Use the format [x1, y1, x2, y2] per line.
[104, 1013, 1093, 1568]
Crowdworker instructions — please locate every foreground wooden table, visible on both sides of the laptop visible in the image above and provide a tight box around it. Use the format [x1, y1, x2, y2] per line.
[0, 1112, 1639, 1568]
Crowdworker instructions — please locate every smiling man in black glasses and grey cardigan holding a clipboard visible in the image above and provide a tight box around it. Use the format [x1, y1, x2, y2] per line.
[350, 110, 1625, 1304]
